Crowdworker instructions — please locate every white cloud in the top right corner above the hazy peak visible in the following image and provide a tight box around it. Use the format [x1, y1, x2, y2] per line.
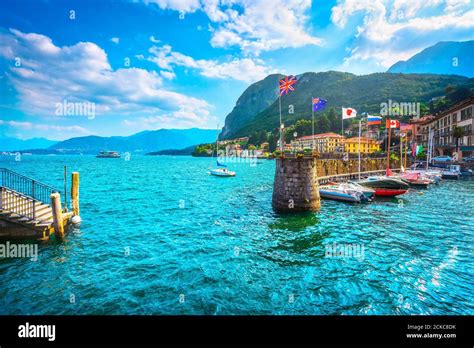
[331, 0, 474, 71]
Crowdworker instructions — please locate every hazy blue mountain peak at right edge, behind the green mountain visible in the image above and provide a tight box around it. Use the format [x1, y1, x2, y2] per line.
[388, 41, 474, 77]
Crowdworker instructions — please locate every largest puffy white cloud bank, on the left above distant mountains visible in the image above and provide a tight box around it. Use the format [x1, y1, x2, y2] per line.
[0, 30, 210, 126]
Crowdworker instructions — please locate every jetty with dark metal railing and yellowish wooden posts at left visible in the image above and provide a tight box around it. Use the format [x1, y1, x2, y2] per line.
[0, 168, 79, 241]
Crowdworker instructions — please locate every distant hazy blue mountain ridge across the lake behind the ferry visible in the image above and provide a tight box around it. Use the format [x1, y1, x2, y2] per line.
[49, 128, 216, 153]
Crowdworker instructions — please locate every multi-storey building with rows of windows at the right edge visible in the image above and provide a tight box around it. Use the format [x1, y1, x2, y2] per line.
[412, 96, 474, 160]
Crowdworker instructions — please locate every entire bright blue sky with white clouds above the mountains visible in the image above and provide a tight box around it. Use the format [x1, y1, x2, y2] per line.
[0, 0, 474, 140]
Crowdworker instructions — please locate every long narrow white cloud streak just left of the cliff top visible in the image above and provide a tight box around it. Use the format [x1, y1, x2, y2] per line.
[148, 45, 275, 83]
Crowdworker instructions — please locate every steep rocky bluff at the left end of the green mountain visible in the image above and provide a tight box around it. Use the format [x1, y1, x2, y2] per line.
[220, 74, 281, 139]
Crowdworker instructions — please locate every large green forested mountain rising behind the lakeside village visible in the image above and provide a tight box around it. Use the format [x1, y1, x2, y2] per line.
[221, 71, 474, 139]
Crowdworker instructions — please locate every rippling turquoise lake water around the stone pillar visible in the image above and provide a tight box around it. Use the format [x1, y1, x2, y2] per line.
[0, 156, 474, 315]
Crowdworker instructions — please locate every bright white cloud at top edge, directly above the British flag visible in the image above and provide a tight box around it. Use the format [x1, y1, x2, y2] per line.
[141, 0, 322, 55]
